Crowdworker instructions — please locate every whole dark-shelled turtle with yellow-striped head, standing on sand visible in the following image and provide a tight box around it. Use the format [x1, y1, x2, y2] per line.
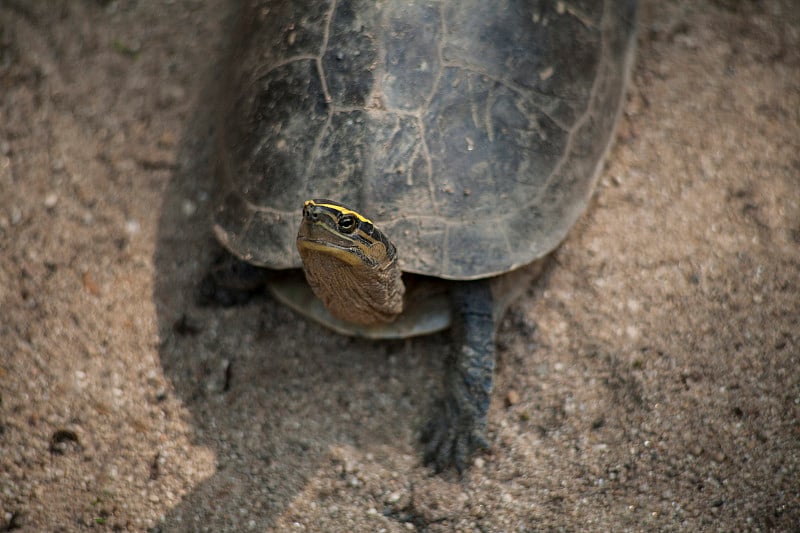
[205, 0, 637, 474]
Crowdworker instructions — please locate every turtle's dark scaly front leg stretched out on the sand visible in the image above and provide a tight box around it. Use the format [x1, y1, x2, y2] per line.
[422, 280, 495, 474]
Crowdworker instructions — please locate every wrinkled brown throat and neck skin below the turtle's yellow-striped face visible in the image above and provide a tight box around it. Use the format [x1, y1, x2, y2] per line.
[297, 221, 405, 326]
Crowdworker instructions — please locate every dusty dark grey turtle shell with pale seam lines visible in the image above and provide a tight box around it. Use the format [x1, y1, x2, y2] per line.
[214, 0, 636, 279]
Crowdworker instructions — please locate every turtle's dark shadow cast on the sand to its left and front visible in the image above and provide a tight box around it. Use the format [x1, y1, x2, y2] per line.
[153, 72, 438, 530]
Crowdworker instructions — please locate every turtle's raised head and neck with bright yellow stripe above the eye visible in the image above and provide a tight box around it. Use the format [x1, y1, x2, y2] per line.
[297, 200, 405, 325]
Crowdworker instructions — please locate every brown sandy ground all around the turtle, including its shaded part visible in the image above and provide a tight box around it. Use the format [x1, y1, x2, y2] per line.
[0, 0, 800, 532]
